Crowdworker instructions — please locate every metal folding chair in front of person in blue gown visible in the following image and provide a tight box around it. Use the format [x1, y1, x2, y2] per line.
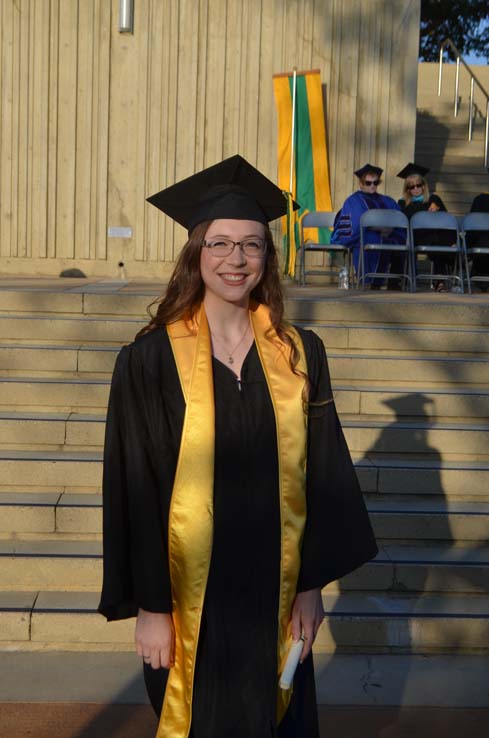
[357, 209, 414, 292]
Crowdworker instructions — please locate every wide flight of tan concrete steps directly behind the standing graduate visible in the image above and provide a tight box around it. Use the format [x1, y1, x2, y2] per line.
[0, 281, 489, 654]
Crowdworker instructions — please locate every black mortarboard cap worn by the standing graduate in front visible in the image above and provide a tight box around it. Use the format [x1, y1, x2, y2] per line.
[147, 154, 299, 231]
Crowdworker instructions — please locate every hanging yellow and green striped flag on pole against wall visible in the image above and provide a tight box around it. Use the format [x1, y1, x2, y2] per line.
[273, 69, 332, 276]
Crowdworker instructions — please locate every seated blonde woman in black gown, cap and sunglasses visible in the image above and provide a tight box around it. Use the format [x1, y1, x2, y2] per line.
[392, 162, 457, 292]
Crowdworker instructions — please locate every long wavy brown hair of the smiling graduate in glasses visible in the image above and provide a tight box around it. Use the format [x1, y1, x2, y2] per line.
[136, 221, 307, 381]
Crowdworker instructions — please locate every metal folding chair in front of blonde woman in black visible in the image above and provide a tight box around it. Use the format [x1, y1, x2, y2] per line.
[410, 210, 470, 292]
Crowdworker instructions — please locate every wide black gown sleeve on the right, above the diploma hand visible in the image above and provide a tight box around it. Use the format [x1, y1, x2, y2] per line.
[297, 331, 378, 591]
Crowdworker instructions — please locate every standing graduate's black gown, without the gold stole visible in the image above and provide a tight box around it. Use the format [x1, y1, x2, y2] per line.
[99, 330, 377, 738]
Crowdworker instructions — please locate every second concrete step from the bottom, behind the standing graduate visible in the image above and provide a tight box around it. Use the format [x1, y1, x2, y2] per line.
[0, 539, 489, 593]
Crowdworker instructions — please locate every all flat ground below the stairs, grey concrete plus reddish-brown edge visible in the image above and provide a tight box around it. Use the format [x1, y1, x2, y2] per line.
[0, 652, 489, 738]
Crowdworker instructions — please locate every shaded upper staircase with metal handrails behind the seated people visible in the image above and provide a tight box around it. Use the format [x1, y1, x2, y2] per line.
[415, 63, 489, 215]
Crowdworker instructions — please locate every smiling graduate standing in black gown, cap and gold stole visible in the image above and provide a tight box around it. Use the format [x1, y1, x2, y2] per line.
[99, 156, 377, 738]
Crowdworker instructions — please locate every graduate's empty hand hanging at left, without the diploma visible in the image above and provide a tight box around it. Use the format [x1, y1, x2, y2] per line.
[134, 608, 175, 669]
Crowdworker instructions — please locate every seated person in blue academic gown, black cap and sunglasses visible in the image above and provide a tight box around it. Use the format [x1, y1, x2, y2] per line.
[331, 164, 403, 289]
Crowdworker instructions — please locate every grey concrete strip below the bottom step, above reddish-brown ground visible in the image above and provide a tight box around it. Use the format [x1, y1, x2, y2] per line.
[0, 651, 489, 704]
